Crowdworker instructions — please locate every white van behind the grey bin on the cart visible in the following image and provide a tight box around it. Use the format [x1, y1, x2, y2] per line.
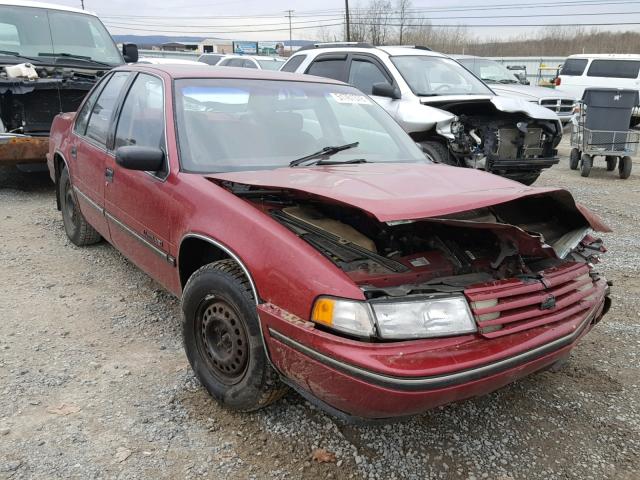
[556, 53, 640, 126]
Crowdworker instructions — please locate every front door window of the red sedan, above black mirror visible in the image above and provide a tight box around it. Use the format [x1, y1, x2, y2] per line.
[115, 73, 165, 156]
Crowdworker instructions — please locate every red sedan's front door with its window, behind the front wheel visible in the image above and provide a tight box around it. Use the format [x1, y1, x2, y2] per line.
[105, 73, 175, 286]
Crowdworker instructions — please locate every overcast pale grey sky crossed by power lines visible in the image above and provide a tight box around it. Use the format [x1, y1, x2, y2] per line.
[49, 0, 640, 40]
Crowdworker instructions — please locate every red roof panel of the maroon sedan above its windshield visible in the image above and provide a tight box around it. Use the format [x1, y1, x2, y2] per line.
[113, 64, 346, 85]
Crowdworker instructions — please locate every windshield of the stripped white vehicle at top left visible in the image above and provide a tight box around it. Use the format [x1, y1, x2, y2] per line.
[0, 5, 123, 66]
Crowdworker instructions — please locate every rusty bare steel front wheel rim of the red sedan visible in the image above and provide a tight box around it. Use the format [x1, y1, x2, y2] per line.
[197, 298, 249, 385]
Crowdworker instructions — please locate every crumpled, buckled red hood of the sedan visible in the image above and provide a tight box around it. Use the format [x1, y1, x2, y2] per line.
[207, 163, 609, 231]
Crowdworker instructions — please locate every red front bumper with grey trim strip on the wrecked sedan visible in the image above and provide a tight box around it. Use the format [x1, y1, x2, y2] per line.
[259, 282, 605, 419]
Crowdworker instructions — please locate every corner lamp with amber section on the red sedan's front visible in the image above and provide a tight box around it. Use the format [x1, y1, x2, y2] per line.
[311, 297, 376, 337]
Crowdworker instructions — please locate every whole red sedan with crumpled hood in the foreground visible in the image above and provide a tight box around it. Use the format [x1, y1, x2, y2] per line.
[48, 65, 610, 418]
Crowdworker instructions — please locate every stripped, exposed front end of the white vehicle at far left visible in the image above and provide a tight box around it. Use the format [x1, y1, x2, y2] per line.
[0, 64, 104, 165]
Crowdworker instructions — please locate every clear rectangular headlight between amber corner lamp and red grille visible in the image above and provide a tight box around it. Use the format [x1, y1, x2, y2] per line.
[371, 297, 476, 339]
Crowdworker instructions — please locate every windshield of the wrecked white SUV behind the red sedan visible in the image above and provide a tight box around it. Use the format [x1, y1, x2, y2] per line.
[391, 55, 493, 96]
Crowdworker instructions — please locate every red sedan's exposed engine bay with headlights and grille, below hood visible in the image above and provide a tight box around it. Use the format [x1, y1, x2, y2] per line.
[219, 176, 608, 342]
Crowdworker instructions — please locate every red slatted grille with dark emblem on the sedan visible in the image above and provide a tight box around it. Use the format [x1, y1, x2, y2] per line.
[464, 263, 597, 338]
